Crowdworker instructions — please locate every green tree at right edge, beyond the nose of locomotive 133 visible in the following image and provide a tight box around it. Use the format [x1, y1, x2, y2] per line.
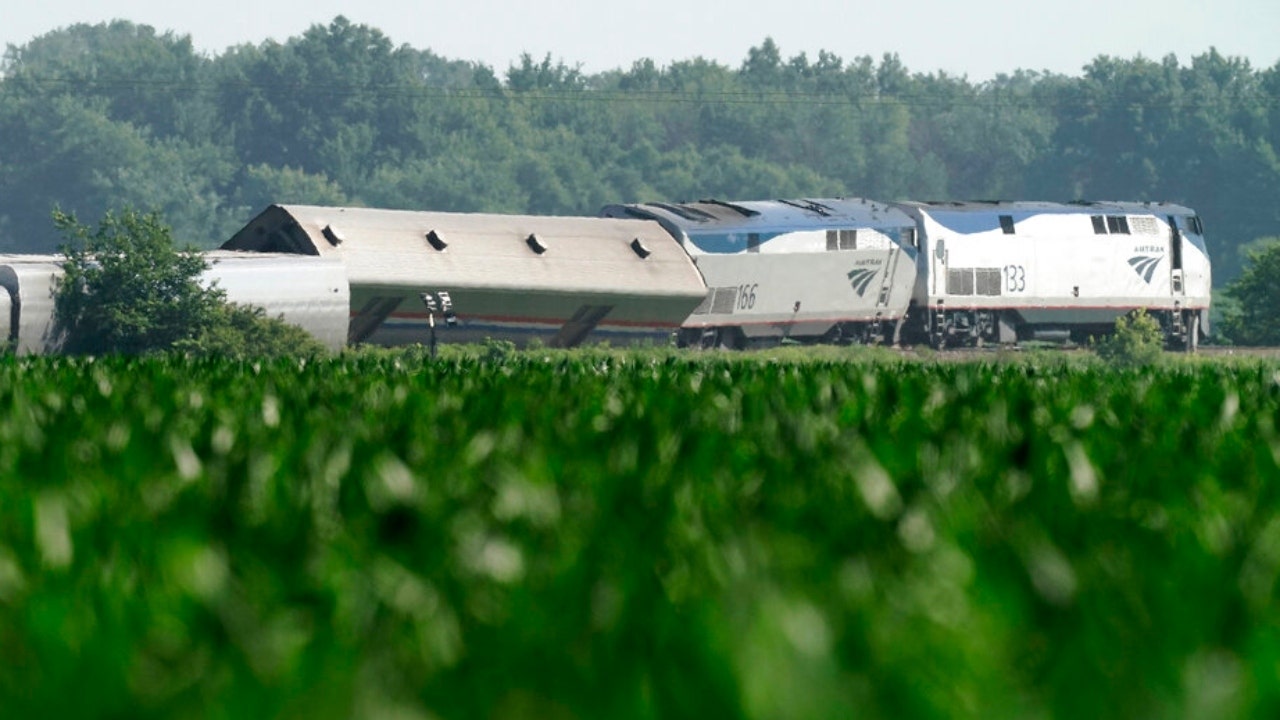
[1222, 237, 1280, 345]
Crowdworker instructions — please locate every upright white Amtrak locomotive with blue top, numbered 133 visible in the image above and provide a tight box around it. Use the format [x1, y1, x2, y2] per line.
[896, 202, 1211, 350]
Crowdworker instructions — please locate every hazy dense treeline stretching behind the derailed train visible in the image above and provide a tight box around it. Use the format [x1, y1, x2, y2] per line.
[0, 18, 1280, 282]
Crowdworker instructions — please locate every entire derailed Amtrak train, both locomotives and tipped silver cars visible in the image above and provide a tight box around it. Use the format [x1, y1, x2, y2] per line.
[0, 197, 1212, 352]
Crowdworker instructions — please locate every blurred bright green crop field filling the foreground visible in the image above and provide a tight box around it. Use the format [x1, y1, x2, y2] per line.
[0, 351, 1280, 719]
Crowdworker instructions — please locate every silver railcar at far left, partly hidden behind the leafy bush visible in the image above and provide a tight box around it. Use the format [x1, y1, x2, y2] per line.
[0, 251, 349, 354]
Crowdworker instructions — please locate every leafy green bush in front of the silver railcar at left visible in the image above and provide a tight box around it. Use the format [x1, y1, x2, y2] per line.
[54, 209, 323, 356]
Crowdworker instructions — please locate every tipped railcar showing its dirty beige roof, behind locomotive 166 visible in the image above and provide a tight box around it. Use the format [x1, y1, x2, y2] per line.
[223, 205, 707, 347]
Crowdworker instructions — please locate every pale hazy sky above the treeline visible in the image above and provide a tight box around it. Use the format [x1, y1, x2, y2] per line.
[0, 0, 1280, 82]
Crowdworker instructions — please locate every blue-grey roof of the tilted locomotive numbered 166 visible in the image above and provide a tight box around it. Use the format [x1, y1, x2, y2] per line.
[600, 197, 911, 231]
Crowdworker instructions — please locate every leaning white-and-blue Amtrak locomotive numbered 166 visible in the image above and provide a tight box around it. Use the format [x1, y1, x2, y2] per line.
[602, 199, 916, 347]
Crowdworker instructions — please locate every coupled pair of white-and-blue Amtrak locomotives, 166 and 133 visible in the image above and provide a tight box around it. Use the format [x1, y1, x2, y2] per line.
[600, 199, 1212, 351]
